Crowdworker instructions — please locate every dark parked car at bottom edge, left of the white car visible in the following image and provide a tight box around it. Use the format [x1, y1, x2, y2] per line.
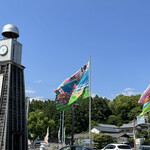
[59, 145, 92, 150]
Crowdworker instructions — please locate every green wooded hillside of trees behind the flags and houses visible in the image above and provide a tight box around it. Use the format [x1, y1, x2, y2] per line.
[28, 95, 142, 139]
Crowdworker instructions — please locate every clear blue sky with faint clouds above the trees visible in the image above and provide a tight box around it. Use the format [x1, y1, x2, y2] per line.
[0, 0, 150, 100]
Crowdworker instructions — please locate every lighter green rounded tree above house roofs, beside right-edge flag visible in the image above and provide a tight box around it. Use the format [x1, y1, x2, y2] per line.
[108, 95, 142, 126]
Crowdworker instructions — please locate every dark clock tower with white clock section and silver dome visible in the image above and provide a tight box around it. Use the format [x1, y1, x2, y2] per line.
[0, 24, 28, 150]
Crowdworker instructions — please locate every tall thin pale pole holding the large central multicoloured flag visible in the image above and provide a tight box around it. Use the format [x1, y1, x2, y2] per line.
[89, 56, 92, 148]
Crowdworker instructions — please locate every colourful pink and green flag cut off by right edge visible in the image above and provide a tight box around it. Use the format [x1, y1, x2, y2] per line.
[139, 85, 150, 118]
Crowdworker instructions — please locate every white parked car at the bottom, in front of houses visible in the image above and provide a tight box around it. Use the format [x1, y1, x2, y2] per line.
[101, 144, 132, 150]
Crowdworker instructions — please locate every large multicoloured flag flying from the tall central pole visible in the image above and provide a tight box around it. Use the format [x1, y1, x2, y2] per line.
[54, 62, 89, 111]
